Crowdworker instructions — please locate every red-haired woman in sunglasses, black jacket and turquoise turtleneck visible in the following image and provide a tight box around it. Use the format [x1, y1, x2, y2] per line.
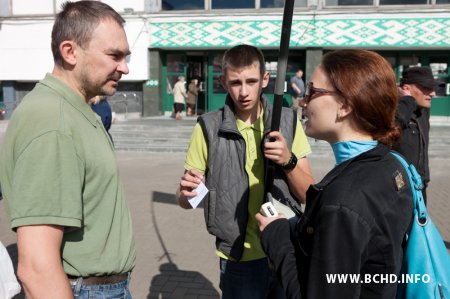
[256, 50, 413, 299]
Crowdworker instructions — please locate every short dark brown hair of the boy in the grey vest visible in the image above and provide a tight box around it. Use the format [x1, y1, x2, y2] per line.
[222, 45, 266, 77]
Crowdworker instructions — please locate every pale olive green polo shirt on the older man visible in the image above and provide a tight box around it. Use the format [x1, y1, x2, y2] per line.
[0, 74, 136, 276]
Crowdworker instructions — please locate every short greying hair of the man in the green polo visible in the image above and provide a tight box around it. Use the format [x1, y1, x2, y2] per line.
[51, 1, 125, 65]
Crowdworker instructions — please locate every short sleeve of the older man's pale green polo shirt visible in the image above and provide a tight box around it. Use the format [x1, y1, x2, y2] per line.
[8, 131, 82, 228]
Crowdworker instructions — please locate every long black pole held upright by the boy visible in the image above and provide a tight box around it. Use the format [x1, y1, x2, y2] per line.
[265, 0, 295, 202]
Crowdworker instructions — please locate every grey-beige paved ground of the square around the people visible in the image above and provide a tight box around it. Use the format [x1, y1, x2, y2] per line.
[0, 118, 450, 299]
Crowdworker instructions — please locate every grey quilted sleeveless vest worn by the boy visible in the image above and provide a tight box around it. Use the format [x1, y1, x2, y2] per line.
[198, 95, 297, 261]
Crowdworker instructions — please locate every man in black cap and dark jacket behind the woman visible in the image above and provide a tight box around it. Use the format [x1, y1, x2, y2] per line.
[394, 67, 444, 203]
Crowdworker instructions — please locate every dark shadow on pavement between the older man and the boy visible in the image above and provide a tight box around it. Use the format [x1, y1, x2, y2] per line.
[147, 191, 220, 299]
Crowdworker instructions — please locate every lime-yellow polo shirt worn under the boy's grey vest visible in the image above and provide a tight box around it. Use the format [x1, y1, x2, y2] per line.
[184, 109, 311, 261]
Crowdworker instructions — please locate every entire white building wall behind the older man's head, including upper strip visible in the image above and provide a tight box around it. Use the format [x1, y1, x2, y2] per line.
[0, 0, 149, 81]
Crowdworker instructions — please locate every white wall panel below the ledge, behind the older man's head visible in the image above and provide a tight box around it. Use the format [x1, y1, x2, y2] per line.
[0, 17, 149, 81]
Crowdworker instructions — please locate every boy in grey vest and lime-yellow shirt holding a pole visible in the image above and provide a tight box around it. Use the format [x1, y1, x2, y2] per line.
[176, 45, 313, 299]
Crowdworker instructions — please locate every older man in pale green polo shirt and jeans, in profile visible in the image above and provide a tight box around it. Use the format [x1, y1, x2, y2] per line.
[0, 1, 136, 299]
